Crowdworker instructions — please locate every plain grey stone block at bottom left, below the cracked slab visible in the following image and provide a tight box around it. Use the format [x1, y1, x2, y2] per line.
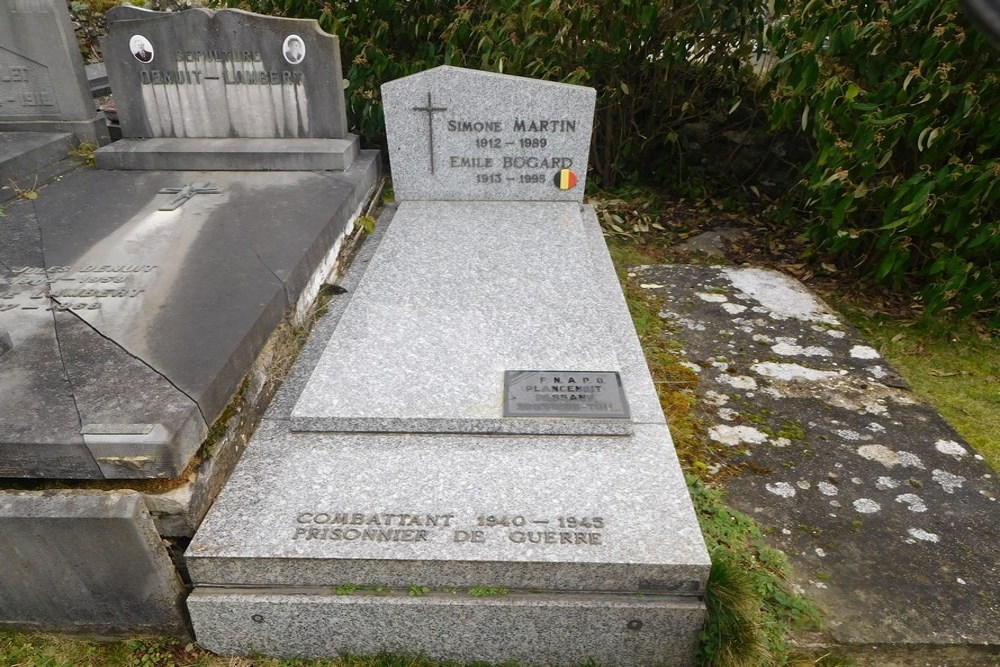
[0, 491, 185, 634]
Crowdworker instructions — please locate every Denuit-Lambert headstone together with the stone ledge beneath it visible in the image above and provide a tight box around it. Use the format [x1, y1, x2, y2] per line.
[97, 7, 358, 170]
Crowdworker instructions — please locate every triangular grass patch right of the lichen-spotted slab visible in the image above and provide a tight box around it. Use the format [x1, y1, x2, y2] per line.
[837, 303, 1000, 472]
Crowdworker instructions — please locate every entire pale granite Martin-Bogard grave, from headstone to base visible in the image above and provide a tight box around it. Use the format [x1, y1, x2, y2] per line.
[186, 67, 709, 665]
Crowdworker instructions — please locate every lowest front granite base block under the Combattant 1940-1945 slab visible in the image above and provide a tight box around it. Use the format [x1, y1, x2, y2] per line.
[188, 587, 705, 667]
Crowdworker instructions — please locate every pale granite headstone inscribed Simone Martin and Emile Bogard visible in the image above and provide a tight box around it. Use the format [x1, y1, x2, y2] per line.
[382, 66, 596, 202]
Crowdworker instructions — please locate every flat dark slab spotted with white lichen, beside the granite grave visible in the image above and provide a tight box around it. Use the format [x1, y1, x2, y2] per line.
[629, 265, 1000, 665]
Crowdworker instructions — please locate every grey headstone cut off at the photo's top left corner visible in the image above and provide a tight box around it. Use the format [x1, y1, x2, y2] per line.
[0, 0, 107, 144]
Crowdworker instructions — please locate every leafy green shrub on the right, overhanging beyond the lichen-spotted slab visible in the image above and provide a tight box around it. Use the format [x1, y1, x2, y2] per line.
[769, 0, 1000, 323]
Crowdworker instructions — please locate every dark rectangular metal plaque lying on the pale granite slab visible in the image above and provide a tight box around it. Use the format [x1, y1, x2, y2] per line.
[503, 371, 630, 419]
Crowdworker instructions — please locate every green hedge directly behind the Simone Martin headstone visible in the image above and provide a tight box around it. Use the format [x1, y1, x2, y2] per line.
[217, 0, 762, 186]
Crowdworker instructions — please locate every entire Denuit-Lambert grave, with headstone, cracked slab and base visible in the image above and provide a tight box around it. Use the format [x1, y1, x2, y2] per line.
[0, 9, 380, 633]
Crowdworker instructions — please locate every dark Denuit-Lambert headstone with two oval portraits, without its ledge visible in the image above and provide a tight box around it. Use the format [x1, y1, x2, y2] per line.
[102, 7, 348, 139]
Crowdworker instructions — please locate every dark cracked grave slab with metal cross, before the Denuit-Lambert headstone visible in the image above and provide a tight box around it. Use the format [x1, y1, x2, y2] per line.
[0, 151, 379, 479]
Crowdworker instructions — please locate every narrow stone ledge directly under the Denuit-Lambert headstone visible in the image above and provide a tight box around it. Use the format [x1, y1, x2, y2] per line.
[94, 134, 359, 171]
